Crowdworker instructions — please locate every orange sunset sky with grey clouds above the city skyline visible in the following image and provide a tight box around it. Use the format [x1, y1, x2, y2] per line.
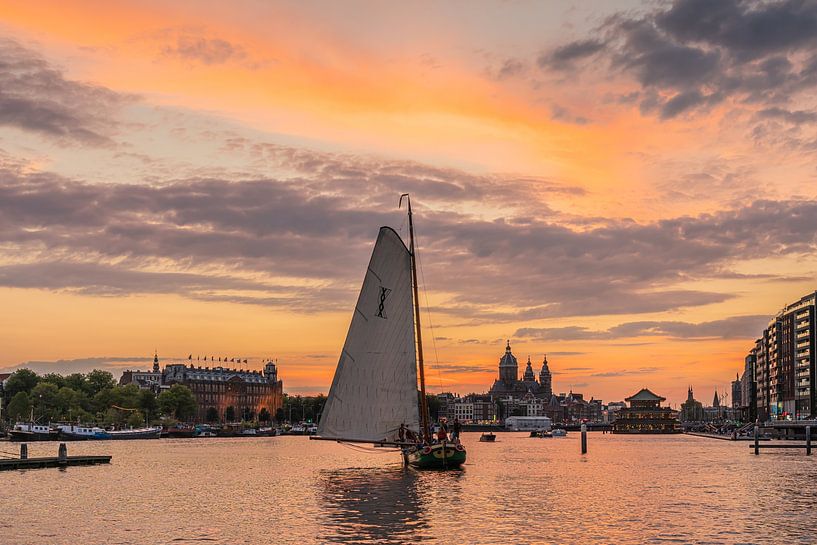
[0, 0, 817, 403]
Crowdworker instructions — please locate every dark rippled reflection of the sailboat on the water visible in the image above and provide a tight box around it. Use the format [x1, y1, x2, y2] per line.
[321, 466, 427, 544]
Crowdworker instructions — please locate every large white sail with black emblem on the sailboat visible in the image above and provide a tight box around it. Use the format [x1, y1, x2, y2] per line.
[318, 227, 420, 442]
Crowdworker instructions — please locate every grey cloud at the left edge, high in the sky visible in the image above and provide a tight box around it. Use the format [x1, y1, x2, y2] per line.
[0, 38, 134, 146]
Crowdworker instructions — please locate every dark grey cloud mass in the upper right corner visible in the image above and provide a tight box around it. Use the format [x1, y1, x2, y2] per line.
[539, 0, 817, 119]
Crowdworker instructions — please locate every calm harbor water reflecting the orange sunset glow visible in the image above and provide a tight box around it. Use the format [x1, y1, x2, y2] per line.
[0, 433, 817, 545]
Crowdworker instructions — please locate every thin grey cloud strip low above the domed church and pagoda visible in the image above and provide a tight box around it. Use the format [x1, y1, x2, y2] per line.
[514, 315, 770, 341]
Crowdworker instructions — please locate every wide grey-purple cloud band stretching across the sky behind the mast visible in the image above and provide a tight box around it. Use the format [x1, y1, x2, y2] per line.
[0, 142, 817, 318]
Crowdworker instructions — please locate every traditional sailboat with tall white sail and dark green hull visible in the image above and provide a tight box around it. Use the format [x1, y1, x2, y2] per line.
[311, 194, 466, 469]
